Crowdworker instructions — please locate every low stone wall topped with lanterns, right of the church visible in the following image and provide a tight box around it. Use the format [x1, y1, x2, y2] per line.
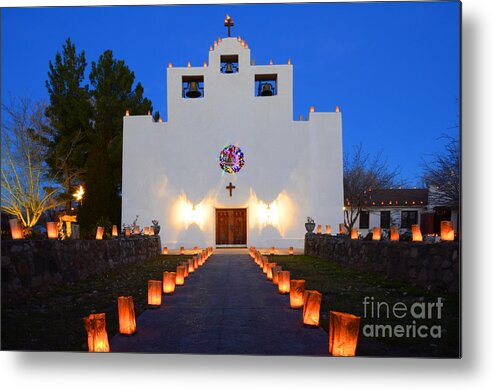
[305, 233, 460, 292]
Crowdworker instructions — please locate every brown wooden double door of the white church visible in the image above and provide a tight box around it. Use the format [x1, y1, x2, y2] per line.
[216, 209, 247, 246]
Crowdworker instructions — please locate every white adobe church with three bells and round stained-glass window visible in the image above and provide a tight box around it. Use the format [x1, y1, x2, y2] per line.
[122, 17, 343, 248]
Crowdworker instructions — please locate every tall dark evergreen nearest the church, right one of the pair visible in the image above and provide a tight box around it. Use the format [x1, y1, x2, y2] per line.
[79, 50, 152, 234]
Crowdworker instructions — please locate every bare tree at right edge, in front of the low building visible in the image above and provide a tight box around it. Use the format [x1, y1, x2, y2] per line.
[423, 135, 460, 209]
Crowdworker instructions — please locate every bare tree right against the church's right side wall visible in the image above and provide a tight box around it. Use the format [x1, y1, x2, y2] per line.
[344, 145, 402, 231]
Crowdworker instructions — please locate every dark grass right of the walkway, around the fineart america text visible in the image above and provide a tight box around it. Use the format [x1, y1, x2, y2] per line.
[269, 256, 460, 357]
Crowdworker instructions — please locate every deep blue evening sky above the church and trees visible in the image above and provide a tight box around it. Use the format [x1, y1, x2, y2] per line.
[1, 2, 460, 186]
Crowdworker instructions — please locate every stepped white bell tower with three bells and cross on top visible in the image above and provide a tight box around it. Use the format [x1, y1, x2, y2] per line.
[167, 15, 293, 127]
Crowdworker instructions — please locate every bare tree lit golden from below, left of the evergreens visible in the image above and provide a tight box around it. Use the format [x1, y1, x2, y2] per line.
[1, 99, 60, 230]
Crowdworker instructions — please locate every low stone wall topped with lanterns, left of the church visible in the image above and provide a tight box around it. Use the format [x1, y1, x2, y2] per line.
[1, 236, 161, 300]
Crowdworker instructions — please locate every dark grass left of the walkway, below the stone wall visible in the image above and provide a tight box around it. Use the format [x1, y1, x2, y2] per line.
[2, 256, 188, 351]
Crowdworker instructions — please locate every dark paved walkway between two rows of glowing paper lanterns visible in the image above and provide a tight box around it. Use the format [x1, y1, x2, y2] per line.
[110, 252, 328, 356]
